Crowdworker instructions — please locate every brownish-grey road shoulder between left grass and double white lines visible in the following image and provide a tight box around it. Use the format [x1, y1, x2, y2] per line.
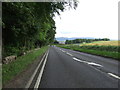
[3, 53, 45, 88]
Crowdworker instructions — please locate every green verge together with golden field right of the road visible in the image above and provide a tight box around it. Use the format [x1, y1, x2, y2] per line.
[58, 41, 120, 60]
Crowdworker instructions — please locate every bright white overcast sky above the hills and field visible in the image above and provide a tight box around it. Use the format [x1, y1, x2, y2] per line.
[54, 0, 120, 40]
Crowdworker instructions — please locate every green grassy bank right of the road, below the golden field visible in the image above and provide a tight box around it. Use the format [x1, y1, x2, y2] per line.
[58, 45, 120, 60]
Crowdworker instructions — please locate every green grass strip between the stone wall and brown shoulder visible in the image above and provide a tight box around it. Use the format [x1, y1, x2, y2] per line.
[2, 46, 48, 84]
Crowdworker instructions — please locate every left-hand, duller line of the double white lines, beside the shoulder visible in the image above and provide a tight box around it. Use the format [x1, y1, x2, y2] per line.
[25, 52, 47, 88]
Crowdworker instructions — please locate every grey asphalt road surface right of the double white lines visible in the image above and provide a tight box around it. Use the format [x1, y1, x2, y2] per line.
[39, 46, 120, 88]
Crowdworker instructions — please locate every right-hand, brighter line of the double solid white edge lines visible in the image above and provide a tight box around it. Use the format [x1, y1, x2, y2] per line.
[34, 51, 49, 89]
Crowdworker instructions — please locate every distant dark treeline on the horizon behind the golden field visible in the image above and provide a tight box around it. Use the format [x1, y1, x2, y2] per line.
[65, 38, 110, 44]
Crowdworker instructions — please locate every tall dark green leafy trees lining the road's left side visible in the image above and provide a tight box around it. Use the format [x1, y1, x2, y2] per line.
[2, 0, 77, 57]
